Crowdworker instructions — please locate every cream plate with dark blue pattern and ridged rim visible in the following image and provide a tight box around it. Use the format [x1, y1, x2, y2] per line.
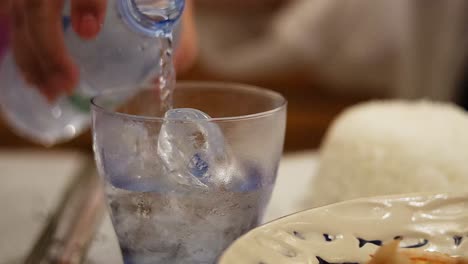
[219, 194, 468, 264]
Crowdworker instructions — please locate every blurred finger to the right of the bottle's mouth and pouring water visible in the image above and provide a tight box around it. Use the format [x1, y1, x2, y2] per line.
[174, 0, 198, 73]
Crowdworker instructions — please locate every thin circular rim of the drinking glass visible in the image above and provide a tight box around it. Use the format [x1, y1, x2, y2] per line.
[91, 81, 288, 122]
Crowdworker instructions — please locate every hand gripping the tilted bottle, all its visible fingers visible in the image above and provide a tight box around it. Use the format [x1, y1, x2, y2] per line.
[5, 0, 196, 101]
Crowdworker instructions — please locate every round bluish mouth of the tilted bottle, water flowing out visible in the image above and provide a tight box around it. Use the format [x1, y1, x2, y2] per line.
[117, 0, 185, 37]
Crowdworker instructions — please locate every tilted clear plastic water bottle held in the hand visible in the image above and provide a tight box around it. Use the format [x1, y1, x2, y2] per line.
[0, 0, 184, 146]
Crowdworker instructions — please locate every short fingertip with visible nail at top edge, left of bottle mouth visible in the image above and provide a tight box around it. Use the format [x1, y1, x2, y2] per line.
[71, 0, 107, 39]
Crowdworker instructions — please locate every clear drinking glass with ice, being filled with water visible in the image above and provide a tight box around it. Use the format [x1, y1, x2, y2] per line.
[92, 82, 287, 264]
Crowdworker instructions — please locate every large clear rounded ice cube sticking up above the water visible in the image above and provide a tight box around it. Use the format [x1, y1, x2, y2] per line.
[158, 108, 241, 187]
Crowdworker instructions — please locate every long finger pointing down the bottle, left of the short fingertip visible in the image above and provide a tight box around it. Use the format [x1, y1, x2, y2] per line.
[24, 0, 78, 96]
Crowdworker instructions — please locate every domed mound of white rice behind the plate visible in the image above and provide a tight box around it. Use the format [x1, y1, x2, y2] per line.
[306, 101, 468, 207]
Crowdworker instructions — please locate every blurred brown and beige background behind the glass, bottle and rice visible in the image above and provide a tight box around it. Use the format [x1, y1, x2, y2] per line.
[0, 0, 468, 152]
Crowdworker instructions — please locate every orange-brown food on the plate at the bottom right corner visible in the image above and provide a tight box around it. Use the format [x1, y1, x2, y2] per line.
[368, 240, 468, 264]
